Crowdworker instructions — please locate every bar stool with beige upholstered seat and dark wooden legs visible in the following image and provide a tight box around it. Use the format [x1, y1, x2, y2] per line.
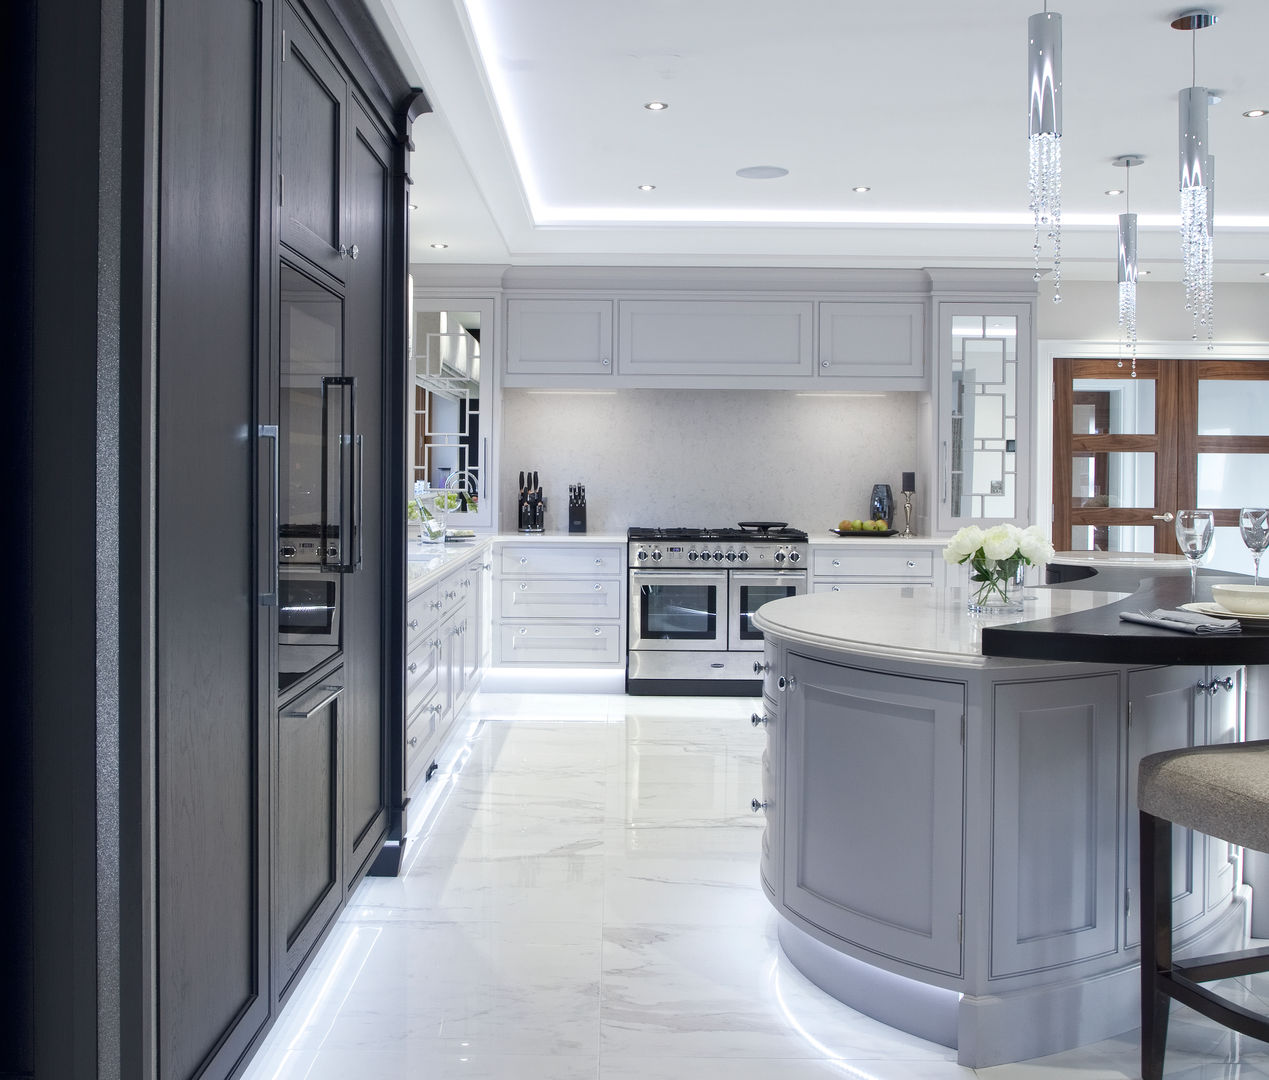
[1137, 740, 1269, 1080]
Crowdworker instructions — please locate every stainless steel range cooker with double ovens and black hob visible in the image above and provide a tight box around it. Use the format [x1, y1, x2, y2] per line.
[626, 522, 807, 694]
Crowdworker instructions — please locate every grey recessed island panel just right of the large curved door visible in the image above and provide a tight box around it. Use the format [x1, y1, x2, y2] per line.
[991, 673, 1121, 977]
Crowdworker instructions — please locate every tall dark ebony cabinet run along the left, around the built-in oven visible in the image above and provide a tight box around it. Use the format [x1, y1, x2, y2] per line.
[21, 0, 419, 1080]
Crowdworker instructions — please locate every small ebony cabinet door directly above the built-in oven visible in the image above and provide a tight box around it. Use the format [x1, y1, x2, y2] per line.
[278, 4, 348, 279]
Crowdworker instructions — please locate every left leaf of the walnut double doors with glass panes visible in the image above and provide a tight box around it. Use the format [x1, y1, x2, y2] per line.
[1053, 358, 1179, 552]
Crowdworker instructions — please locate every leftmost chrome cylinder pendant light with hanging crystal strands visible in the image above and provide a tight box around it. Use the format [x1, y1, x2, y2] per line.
[1027, 4, 1062, 303]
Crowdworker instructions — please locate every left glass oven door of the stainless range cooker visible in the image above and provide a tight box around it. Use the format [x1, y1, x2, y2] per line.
[631, 570, 727, 651]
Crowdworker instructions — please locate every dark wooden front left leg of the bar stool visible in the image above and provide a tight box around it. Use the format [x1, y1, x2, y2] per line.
[1140, 813, 1173, 1080]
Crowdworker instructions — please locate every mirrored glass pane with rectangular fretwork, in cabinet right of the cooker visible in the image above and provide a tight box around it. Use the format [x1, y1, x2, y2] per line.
[949, 315, 1018, 518]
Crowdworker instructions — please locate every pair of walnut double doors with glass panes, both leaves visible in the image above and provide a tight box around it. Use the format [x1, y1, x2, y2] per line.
[1053, 358, 1269, 558]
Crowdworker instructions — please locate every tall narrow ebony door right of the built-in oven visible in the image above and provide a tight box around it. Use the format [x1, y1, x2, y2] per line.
[344, 99, 388, 885]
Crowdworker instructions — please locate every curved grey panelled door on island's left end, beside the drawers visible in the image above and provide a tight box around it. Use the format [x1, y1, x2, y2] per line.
[780, 655, 964, 975]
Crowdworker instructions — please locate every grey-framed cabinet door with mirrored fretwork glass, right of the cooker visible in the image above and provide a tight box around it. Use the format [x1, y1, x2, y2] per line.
[934, 303, 1033, 533]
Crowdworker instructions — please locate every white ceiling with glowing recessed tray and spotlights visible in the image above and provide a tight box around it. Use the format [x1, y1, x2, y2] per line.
[369, 0, 1269, 282]
